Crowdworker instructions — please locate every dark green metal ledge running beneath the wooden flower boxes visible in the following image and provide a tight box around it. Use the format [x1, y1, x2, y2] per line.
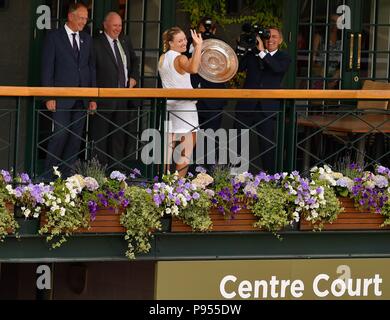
[0, 231, 390, 263]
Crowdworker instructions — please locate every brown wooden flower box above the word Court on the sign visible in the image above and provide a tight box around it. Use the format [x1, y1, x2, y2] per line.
[299, 198, 390, 230]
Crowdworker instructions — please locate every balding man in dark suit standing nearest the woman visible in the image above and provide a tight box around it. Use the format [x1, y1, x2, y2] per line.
[90, 12, 138, 169]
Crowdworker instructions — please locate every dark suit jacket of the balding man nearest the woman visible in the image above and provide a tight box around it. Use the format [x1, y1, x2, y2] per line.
[94, 33, 138, 88]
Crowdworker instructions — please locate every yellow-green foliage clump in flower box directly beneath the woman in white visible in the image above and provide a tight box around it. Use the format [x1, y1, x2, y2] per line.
[177, 190, 212, 231]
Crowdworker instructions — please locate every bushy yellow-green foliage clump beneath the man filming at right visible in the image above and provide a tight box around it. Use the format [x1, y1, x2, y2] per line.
[250, 183, 292, 235]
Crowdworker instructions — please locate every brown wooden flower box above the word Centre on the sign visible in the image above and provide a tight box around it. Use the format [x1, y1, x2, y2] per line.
[171, 208, 259, 232]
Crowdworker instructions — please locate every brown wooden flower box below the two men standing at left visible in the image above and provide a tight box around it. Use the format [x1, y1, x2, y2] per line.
[40, 208, 126, 233]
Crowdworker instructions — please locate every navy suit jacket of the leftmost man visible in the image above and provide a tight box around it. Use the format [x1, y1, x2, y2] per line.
[41, 27, 96, 107]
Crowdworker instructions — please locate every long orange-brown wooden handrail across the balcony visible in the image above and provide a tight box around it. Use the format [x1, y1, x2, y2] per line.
[0, 86, 390, 100]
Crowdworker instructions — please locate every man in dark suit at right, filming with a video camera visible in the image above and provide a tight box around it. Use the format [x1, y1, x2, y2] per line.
[236, 27, 291, 172]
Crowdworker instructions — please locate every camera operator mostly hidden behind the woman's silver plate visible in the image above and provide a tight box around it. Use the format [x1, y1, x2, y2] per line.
[186, 17, 226, 133]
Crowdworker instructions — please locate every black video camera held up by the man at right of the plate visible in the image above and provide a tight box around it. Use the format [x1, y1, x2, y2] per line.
[236, 22, 271, 56]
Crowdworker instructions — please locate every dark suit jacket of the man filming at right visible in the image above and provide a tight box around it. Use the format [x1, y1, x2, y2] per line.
[240, 50, 291, 89]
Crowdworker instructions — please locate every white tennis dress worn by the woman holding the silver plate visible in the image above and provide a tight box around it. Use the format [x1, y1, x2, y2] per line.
[158, 50, 199, 133]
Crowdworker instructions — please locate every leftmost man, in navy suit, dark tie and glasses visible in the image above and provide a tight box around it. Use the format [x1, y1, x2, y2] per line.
[41, 3, 96, 176]
